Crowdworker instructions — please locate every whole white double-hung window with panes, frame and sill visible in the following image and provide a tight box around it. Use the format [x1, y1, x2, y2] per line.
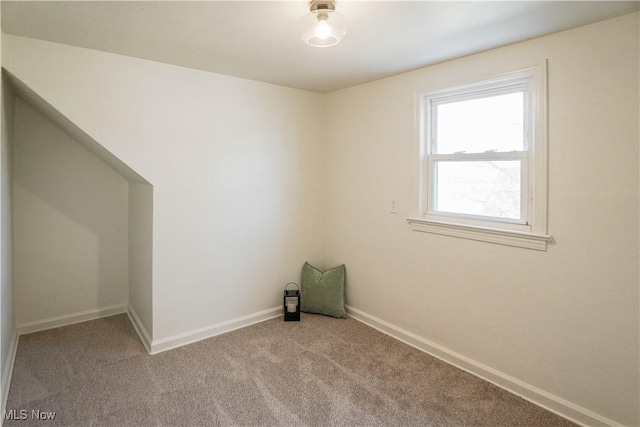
[409, 62, 551, 250]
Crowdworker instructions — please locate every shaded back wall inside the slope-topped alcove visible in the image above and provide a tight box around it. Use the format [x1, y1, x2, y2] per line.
[13, 98, 129, 327]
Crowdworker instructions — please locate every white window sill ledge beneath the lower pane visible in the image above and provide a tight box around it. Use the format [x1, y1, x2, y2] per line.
[407, 218, 553, 251]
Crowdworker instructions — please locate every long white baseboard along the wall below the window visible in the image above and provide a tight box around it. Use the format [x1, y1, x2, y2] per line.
[346, 306, 620, 426]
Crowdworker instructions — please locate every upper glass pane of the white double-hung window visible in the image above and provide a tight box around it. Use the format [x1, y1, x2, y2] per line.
[433, 91, 525, 154]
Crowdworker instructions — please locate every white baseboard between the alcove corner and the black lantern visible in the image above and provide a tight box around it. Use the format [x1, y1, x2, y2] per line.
[150, 307, 282, 354]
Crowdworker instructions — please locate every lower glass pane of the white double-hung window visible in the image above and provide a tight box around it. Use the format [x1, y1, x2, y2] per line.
[434, 160, 521, 219]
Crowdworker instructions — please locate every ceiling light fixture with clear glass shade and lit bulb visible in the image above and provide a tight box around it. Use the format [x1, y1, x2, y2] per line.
[300, 0, 347, 47]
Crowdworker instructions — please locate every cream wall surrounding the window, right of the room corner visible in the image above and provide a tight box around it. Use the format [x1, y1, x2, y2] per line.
[326, 14, 640, 425]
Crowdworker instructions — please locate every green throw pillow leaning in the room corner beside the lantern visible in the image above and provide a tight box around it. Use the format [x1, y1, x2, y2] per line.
[300, 262, 347, 319]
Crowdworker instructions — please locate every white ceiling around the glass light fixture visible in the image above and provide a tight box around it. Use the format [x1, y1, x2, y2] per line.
[2, 0, 640, 93]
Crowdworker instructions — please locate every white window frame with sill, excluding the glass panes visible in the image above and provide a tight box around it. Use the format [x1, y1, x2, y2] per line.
[407, 60, 552, 250]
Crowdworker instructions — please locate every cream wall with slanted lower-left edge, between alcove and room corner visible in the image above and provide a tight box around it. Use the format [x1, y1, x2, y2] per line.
[3, 35, 324, 341]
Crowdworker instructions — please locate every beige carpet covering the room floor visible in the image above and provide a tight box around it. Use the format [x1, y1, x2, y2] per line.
[4, 314, 574, 427]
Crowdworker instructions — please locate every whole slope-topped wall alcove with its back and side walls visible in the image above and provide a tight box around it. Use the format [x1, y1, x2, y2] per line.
[4, 71, 153, 350]
